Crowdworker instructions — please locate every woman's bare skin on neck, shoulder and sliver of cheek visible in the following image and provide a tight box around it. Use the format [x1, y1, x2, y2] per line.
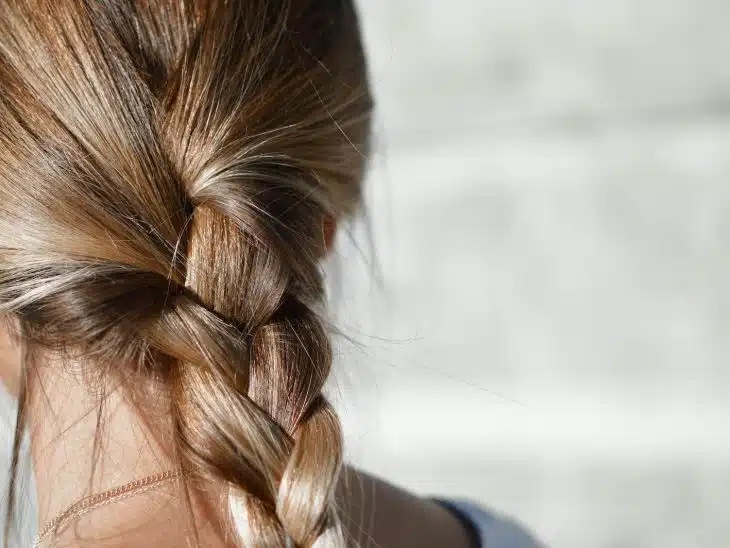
[0, 332, 468, 548]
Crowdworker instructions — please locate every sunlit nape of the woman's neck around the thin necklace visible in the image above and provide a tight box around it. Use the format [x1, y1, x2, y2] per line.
[28, 362, 228, 547]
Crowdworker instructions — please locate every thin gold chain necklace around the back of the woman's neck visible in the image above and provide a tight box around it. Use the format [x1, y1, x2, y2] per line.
[33, 470, 185, 548]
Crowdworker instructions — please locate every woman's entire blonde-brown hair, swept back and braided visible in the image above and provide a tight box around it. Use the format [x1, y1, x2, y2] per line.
[0, 0, 372, 547]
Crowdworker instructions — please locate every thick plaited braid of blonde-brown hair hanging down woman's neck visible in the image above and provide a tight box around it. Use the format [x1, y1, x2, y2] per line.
[152, 198, 342, 546]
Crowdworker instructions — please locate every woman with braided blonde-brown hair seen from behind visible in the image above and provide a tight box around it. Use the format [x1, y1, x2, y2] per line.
[0, 0, 544, 548]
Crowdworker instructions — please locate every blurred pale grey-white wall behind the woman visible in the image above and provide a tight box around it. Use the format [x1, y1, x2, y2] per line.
[0, 0, 730, 548]
